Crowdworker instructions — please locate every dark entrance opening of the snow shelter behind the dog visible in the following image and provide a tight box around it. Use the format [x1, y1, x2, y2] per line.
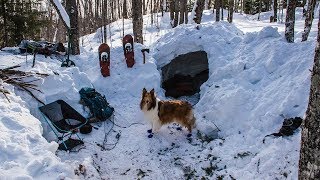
[161, 51, 209, 98]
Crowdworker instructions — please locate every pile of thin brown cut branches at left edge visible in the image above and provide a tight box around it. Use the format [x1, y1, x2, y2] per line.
[0, 66, 49, 105]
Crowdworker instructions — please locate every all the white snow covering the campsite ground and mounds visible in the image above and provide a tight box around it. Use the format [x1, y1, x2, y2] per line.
[0, 8, 317, 179]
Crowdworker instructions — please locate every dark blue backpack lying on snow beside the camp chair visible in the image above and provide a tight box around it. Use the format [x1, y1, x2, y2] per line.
[79, 87, 114, 121]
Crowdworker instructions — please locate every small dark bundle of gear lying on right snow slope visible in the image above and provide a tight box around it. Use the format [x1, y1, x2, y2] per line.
[263, 117, 302, 143]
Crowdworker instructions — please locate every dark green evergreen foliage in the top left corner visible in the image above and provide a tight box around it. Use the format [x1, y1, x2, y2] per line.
[0, 0, 47, 47]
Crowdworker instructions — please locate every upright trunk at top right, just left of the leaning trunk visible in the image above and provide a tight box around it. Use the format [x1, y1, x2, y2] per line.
[285, 0, 297, 43]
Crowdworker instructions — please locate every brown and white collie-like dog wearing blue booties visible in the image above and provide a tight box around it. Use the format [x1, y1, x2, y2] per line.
[140, 88, 196, 138]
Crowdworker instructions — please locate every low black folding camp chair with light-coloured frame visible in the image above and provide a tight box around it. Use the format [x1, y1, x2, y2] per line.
[39, 100, 88, 151]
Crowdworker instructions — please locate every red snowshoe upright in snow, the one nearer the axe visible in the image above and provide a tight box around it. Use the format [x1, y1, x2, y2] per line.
[122, 34, 135, 68]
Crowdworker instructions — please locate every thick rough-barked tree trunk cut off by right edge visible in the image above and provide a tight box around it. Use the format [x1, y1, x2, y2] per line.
[298, 8, 320, 180]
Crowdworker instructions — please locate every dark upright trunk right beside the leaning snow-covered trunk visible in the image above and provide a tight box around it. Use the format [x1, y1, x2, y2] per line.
[66, 0, 80, 55]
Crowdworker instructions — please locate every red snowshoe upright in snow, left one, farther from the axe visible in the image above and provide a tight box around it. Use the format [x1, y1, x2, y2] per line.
[98, 43, 110, 77]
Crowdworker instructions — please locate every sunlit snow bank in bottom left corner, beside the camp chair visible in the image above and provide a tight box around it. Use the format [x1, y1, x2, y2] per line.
[0, 82, 73, 179]
